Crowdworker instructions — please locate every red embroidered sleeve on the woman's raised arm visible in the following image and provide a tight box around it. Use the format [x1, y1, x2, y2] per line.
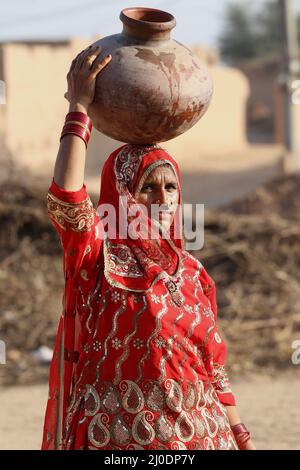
[47, 178, 103, 284]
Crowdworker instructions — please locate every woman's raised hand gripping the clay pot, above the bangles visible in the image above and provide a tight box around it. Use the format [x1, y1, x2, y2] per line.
[65, 46, 112, 111]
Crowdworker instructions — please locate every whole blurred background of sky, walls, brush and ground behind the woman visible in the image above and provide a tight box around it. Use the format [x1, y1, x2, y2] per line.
[0, 0, 300, 449]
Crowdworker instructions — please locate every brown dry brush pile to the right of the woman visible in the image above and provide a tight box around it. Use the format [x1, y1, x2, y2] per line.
[196, 175, 300, 372]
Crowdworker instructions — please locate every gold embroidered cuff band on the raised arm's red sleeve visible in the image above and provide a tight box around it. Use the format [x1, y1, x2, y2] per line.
[47, 191, 95, 232]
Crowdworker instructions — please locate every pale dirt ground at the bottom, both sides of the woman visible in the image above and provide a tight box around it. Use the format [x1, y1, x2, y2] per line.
[0, 366, 300, 450]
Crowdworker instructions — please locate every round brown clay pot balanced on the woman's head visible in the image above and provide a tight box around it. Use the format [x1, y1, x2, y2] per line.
[89, 7, 213, 144]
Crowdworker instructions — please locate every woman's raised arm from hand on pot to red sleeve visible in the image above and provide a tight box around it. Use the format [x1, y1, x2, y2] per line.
[47, 47, 111, 273]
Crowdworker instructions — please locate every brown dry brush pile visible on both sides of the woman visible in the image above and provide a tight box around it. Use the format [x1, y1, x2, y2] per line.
[0, 170, 300, 384]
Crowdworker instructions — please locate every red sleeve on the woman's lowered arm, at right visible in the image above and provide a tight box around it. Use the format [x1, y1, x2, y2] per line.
[200, 266, 236, 406]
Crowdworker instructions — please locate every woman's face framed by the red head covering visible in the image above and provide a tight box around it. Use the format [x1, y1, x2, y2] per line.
[135, 165, 179, 230]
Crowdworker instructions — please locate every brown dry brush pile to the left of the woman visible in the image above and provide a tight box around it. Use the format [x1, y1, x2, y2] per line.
[0, 173, 63, 384]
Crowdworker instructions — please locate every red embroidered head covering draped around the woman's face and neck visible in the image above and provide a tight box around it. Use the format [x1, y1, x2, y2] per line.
[98, 144, 183, 292]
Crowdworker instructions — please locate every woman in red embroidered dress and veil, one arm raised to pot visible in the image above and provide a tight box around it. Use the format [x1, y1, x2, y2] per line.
[42, 48, 254, 450]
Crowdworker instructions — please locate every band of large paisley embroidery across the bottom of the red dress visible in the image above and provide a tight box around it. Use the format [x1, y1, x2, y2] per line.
[64, 379, 237, 450]
